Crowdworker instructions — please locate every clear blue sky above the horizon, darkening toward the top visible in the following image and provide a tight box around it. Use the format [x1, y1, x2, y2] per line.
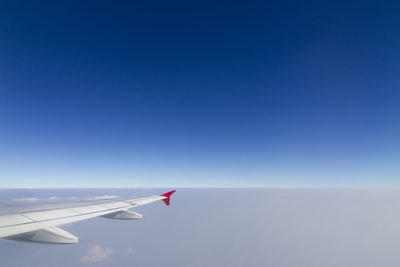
[0, 0, 400, 187]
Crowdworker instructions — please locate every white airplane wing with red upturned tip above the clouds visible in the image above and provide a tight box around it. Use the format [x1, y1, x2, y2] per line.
[0, 190, 175, 244]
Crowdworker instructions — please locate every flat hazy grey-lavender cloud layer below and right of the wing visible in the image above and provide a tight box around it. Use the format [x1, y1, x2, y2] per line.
[0, 189, 400, 267]
